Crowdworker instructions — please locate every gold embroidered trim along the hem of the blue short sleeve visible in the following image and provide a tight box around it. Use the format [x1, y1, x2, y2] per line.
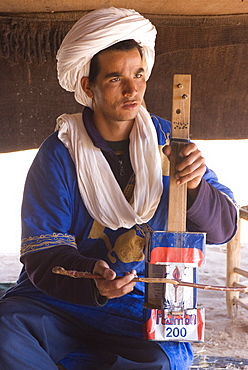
[21, 233, 77, 257]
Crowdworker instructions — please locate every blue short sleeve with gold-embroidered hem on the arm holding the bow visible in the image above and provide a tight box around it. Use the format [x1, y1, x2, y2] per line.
[22, 130, 76, 254]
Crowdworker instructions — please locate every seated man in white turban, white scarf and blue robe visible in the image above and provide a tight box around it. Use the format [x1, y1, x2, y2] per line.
[0, 8, 236, 370]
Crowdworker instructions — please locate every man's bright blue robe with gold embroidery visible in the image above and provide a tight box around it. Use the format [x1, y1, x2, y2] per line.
[6, 111, 236, 370]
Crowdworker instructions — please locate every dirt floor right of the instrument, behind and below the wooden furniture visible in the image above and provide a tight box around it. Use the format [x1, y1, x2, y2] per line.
[192, 245, 248, 370]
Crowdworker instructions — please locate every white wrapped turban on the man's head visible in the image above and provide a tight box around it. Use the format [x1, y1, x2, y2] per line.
[57, 7, 157, 107]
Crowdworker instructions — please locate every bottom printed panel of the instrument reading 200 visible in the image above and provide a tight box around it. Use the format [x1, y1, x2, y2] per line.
[143, 309, 205, 342]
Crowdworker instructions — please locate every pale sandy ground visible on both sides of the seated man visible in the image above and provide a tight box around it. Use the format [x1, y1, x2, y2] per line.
[0, 244, 248, 359]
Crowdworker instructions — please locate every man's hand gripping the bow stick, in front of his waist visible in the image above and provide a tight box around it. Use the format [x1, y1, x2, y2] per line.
[93, 260, 136, 299]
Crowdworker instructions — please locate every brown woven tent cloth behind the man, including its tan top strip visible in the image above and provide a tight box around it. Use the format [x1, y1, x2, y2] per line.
[0, 0, 248, 152]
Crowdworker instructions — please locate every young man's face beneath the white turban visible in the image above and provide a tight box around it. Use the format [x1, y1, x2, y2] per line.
[91, 49, 146, 123]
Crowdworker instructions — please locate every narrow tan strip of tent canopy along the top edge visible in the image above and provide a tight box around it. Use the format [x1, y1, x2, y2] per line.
[0, 0, 248, 15]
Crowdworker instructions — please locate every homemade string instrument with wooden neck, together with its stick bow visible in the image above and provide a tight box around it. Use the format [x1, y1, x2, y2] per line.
[53, 75, 244, 341]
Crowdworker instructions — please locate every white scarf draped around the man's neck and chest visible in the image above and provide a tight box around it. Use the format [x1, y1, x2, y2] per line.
[56, 106, 163, 230]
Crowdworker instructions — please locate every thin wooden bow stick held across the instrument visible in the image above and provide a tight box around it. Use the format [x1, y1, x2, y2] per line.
[52, 266, 248, 293]
